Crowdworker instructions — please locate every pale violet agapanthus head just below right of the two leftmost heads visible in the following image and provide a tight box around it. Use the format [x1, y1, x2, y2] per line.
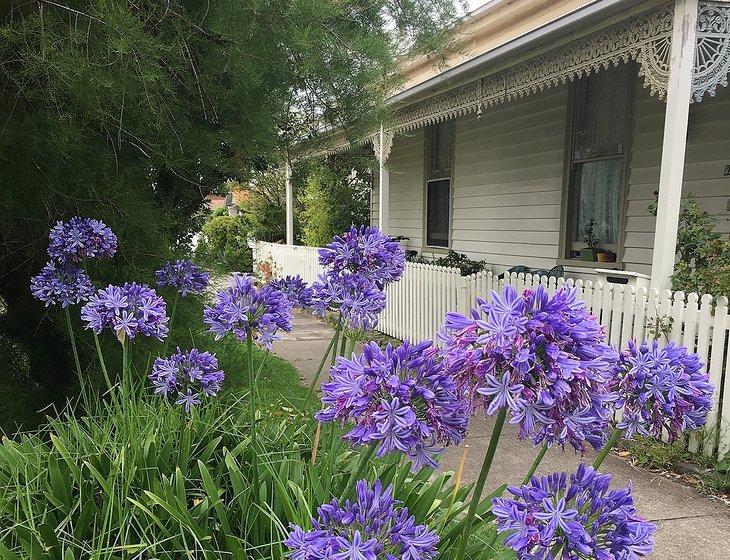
[81, 282, 169, 342]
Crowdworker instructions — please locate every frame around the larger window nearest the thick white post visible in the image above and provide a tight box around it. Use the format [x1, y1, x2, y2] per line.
[558, 63, 637, 268]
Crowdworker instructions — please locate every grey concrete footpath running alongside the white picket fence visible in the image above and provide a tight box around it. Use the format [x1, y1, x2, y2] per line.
[274, 313, 730, 560]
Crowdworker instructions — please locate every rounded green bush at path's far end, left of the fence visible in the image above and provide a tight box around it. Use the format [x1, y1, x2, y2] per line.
[195, 215, 253, 272]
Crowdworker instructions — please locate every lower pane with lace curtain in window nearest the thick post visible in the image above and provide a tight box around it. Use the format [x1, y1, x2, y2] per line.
[573, 158, 622, 245]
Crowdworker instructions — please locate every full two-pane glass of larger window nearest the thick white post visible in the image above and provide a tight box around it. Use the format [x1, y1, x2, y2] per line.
[567, 65, 633, 257]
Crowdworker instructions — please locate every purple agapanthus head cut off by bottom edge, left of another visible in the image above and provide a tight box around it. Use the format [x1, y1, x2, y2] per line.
[284, 480, 439, 560]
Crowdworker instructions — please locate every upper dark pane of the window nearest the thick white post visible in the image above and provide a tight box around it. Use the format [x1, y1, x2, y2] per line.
[573, 65, 632, 160]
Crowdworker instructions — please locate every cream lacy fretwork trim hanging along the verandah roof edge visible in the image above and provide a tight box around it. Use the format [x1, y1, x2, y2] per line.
[300, 0, 730, 159]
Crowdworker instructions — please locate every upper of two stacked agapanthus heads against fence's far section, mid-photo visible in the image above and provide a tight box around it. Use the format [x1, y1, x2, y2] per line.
[319, 226, 406, 289]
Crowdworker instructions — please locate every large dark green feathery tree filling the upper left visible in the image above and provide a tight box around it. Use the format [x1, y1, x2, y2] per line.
[0, 0, 458, 420]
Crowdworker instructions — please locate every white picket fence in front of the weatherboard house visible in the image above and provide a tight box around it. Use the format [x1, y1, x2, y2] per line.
[254, 242, 730, 458]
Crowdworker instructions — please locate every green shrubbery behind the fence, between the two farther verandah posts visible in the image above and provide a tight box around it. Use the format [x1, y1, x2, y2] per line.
[300, 154, 372, 247]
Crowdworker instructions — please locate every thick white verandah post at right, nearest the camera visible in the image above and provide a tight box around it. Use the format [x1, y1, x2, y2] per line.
[651, 0, 698, 290]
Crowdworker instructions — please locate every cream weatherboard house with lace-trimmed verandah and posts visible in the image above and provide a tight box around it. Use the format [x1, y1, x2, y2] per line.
[287, 0, 730, 289]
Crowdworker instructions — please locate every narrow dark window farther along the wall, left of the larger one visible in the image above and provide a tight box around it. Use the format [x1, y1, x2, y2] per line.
[425, 120, 454, 247]
